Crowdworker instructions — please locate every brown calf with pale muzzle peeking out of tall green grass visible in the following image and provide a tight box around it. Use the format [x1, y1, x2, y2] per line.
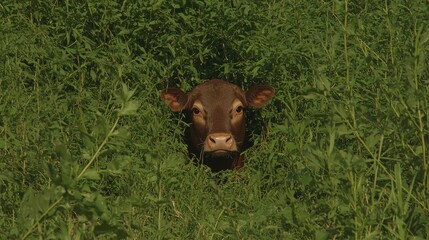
[161, 79, 274, 172]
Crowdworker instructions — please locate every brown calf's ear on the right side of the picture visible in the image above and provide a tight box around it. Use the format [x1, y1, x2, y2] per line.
[246, 85, 275, 108]
